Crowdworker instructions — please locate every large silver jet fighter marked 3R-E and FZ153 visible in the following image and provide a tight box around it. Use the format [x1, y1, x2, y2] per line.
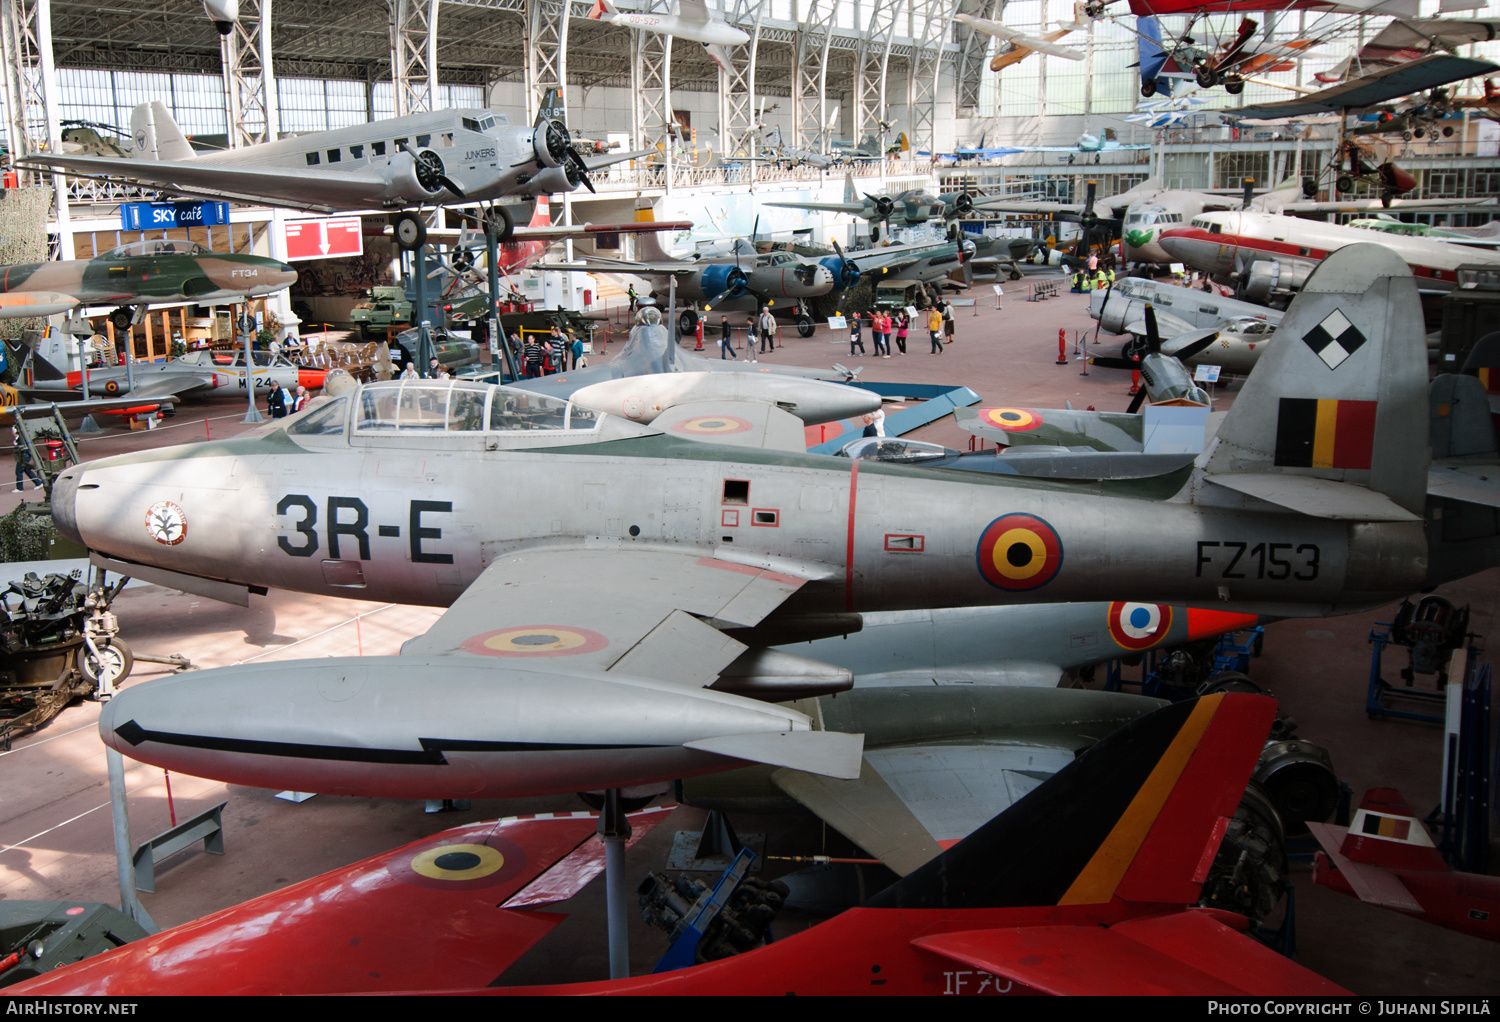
[53, 245, 1428, 797]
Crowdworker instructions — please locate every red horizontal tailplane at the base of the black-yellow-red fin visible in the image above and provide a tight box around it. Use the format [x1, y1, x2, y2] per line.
[912, 909, 1347, 996]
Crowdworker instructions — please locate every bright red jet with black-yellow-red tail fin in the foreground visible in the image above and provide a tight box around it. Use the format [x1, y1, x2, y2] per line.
[6, 693, 1347, 996]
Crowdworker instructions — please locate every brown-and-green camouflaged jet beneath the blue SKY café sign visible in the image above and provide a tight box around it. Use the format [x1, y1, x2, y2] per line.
[0, 239, 297, 332]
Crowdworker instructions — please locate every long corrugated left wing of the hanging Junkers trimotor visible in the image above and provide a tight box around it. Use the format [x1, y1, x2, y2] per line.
[15, 153, 389, 213]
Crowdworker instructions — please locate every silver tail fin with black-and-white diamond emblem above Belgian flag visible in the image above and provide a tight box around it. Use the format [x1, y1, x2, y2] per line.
[1199, 243, 1431, 521]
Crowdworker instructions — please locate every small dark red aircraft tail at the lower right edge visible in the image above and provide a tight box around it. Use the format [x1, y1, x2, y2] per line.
[1308, 788, 1500, 941]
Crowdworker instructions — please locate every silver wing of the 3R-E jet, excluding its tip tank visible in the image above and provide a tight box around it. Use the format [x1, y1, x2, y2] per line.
[402, 543, 833, 687]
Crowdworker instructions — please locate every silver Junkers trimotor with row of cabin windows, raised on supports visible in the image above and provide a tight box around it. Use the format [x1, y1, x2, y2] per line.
[15, 101, 645, 249]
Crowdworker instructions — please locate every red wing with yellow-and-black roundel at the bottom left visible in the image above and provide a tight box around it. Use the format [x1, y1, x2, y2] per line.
[5, 807, 672, 996]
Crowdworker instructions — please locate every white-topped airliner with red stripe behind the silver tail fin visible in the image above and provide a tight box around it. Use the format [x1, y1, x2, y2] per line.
[1157, 208, 1500, 302]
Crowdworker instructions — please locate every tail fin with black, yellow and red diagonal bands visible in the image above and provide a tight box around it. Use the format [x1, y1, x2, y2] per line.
[866, 693, 1277, 908]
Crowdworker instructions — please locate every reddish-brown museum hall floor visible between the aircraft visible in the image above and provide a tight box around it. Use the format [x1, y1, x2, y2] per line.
[0, 274, 1500, 995]
